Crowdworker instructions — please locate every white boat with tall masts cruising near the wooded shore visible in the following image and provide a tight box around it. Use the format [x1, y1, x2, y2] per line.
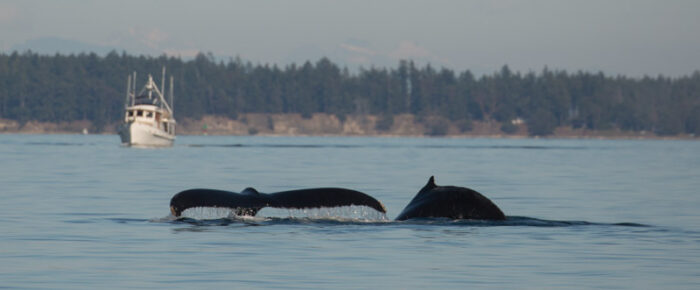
[119, 68, 175, 147]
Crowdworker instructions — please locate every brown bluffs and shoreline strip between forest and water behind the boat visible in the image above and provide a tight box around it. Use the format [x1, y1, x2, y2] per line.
[0, 113, 699, 140]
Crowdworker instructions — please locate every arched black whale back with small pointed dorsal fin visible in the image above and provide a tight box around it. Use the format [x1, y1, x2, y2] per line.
[396, 176, 506, 220]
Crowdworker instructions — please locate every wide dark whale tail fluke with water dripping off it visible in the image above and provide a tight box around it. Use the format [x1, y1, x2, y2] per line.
[170, 187, 386, 217]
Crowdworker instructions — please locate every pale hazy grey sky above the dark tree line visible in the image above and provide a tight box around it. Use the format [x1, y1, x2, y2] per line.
[0, 0, 700, 76]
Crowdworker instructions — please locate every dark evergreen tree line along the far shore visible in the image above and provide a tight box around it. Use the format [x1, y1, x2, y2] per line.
[0, 51, 700, 135]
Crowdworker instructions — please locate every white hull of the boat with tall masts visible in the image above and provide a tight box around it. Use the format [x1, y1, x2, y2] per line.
[119, 122, 175, 147]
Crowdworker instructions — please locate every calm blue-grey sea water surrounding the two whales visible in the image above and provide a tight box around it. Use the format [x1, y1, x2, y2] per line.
[0, 135, 700, 289]
